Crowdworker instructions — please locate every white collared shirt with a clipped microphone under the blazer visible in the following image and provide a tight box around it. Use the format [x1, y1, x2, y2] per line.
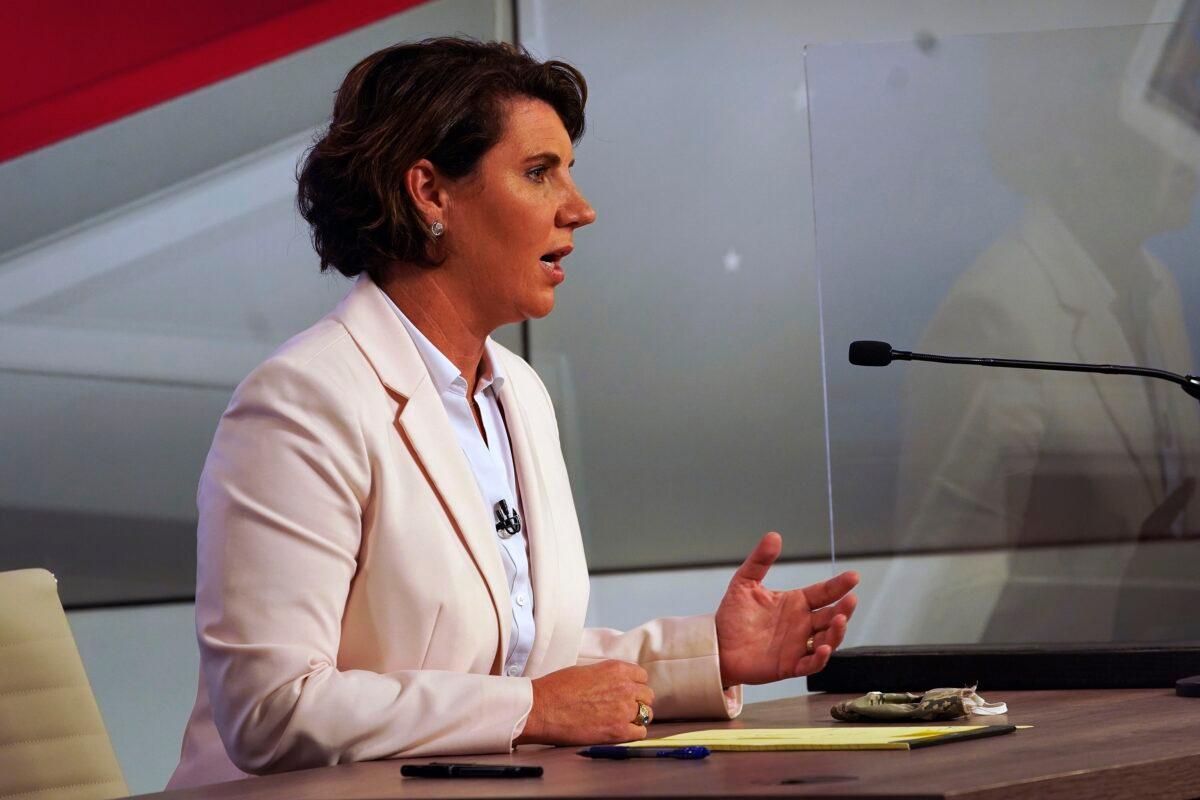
[379, 289, 534, 678]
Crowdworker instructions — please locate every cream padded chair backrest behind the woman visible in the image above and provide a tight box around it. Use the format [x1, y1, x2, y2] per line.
[0, 570, 130, 800]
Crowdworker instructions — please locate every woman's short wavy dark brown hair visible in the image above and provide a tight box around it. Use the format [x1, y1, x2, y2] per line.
[296, 37, 588, 282]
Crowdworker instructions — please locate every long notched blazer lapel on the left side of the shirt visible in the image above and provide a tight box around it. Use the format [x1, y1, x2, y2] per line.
[334, 273, 511, 672]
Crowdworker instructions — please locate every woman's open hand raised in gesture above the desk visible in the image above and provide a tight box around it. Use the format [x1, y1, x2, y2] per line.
[716, 531, 858, 686]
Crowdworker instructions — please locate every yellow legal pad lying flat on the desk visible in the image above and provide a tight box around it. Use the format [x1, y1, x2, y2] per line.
[625, 724, 1027, 751]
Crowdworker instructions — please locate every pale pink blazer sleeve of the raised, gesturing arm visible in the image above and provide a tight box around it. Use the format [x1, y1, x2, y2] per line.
[578, 614, 742, 720]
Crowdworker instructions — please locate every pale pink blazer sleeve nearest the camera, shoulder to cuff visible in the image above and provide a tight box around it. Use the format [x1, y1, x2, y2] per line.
[196, 352, 533, 774]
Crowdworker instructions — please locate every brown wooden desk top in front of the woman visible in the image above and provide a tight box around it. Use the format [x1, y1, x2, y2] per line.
[144, 688, 1200, 800]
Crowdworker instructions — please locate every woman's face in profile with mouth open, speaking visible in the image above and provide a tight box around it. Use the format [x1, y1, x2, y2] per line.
[443, 98, 595, 330]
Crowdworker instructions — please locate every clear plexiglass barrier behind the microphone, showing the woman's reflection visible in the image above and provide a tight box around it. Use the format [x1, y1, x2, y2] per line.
[805, 17, 1200, 644]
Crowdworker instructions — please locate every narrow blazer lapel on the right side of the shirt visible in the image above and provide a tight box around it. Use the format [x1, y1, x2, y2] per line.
[493, 350, 559, 667]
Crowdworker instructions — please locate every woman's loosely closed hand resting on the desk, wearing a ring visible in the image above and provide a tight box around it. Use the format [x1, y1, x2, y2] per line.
[514, 661, 654, 745]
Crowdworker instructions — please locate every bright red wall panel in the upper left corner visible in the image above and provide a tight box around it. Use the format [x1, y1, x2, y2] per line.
[0, 0, 432, 161]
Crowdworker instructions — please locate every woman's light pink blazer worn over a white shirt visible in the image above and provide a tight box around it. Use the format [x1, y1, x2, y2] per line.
[168, 277, 740, 788]
